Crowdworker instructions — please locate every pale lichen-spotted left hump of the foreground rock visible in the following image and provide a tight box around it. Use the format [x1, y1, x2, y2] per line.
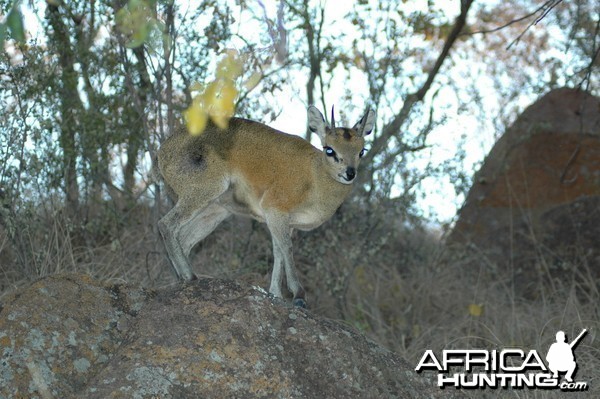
[0, 275, 150, 399]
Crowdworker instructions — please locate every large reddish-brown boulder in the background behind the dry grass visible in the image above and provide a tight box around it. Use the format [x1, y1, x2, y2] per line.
[447, 89, 600, 288]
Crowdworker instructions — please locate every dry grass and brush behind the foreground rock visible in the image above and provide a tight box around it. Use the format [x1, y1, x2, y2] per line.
[0, 200, 600, 397]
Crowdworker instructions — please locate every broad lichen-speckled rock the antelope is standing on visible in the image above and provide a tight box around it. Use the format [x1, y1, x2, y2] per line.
[0, 275, 460, 399]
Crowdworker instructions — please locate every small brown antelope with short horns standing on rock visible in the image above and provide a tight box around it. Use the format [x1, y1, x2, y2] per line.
[157, 108, 374, 303]
